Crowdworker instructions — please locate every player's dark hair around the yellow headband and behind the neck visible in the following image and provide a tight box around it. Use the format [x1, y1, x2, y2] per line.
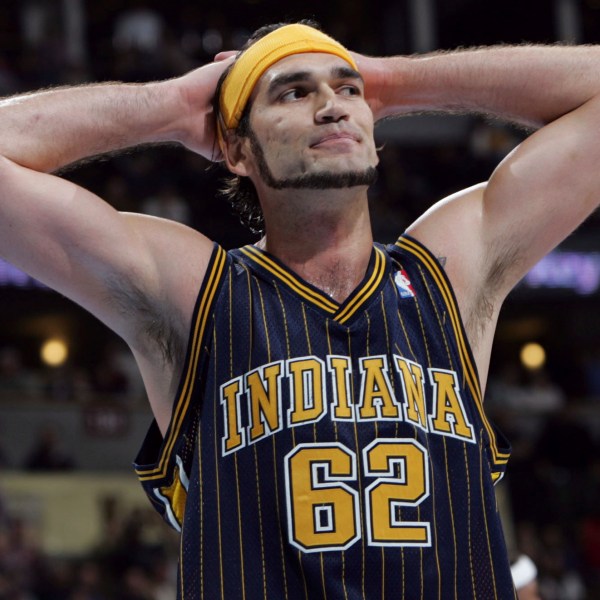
[213, 19, 320, 233]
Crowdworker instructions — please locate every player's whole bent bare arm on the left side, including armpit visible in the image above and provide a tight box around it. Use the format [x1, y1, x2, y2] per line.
[0, 61, 228, 429]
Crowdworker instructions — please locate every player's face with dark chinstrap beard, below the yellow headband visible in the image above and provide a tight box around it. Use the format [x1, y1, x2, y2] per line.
[237, 53, 378, 189]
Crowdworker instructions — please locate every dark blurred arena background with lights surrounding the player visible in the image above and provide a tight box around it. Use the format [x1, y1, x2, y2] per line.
[0, 0, 600, 600]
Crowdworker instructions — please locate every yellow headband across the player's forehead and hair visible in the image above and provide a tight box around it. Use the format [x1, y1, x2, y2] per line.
[219, 24, 356, 136]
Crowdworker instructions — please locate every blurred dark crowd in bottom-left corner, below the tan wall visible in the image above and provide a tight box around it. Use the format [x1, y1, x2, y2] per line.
[0, 498, 178, 600]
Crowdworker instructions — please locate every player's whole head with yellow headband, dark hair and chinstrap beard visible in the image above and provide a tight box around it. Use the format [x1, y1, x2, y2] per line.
[214, 23, 377, 230]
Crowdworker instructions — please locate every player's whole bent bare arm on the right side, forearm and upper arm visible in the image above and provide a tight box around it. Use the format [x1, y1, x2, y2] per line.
[359, 46, 600, 299]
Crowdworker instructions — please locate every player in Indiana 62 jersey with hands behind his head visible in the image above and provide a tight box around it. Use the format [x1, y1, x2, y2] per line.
[0, 19, 600, 600]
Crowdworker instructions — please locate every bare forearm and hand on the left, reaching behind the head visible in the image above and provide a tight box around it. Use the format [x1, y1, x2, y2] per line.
[0, 60, 230, 172]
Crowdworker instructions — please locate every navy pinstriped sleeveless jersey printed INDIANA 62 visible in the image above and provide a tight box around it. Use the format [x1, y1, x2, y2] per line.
[136, 236, 515, 600]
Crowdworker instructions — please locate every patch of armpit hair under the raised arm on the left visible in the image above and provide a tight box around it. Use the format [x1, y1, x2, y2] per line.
[107, 277, 185, 365]
